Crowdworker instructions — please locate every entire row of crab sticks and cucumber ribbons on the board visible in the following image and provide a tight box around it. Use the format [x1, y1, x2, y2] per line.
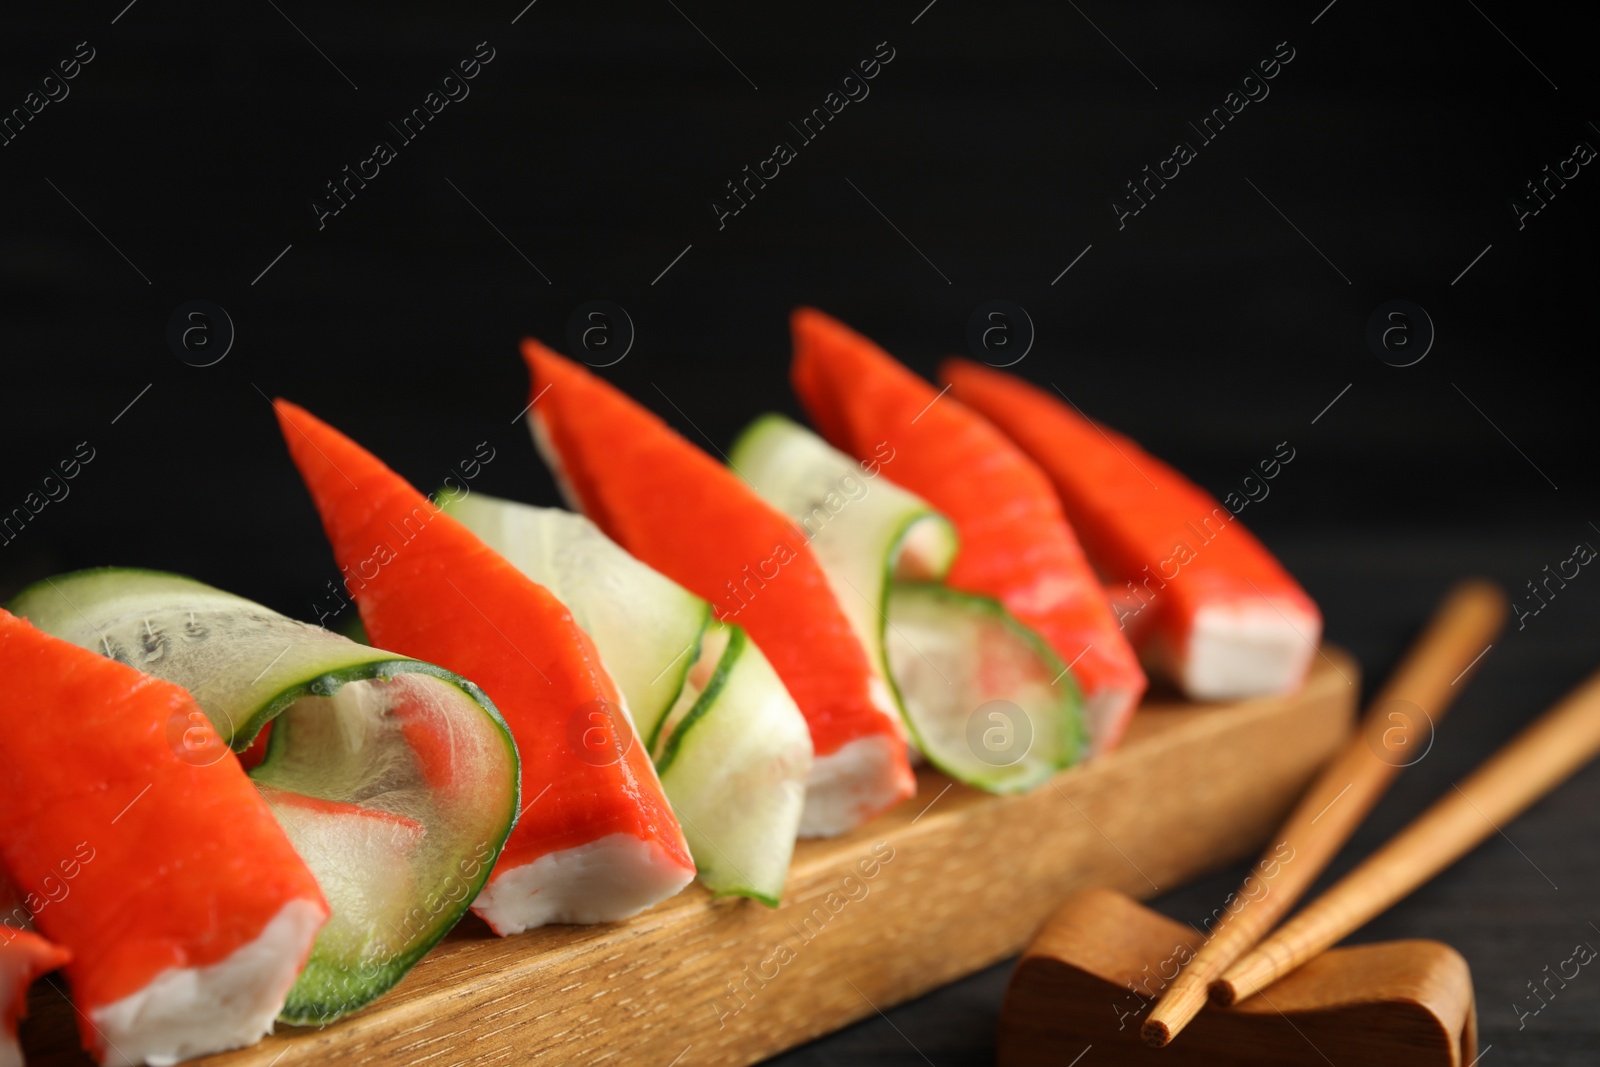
[0, 309, 1568, 1067]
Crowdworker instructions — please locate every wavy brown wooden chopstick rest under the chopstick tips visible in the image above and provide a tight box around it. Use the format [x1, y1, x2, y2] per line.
[998, 889, 1478, 1067]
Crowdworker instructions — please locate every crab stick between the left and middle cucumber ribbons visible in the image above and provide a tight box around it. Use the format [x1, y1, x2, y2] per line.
[275, 400, 694, 934]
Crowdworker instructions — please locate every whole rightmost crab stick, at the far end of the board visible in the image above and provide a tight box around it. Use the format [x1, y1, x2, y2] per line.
[942, 360, 1322, 701]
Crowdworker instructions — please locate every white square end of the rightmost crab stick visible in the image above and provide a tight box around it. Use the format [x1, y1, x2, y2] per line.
[1173, 597, 1322, 701]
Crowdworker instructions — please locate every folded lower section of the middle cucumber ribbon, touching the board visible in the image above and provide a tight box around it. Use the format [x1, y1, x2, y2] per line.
[651, 622, 811, 907]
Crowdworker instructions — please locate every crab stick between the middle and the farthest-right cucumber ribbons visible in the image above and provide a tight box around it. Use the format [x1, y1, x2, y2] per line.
[522, 339, 917, 837]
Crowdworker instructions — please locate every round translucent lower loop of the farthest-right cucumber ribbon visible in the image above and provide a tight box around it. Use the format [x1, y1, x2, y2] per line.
[888, 582, 1086, 793]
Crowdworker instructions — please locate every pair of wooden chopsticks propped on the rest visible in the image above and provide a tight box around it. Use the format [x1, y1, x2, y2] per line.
[1142, 581, 1600, 1046]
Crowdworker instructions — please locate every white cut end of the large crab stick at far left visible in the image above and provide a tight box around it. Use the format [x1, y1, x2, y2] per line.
[90, 901, 323, 1067]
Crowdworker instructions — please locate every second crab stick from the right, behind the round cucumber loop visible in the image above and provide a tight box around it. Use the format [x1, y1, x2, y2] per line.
[790, 307, 1146, 752]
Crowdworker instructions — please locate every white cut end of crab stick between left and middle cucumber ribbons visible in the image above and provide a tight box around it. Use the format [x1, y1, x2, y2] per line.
[472, 833, 694, 937]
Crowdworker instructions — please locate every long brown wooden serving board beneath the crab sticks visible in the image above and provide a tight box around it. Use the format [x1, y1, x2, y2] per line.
[22, 648, 1358, 1067]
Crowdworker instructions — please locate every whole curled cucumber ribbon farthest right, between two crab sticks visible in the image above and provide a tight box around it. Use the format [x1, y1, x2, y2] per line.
[728, 414, 1083, 792]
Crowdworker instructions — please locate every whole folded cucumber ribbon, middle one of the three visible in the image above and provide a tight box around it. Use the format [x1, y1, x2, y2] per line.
[443, 493, 811, 907]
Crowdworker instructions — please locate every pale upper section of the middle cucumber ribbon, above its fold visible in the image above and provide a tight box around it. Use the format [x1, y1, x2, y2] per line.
[434, 491, 710, 737]
